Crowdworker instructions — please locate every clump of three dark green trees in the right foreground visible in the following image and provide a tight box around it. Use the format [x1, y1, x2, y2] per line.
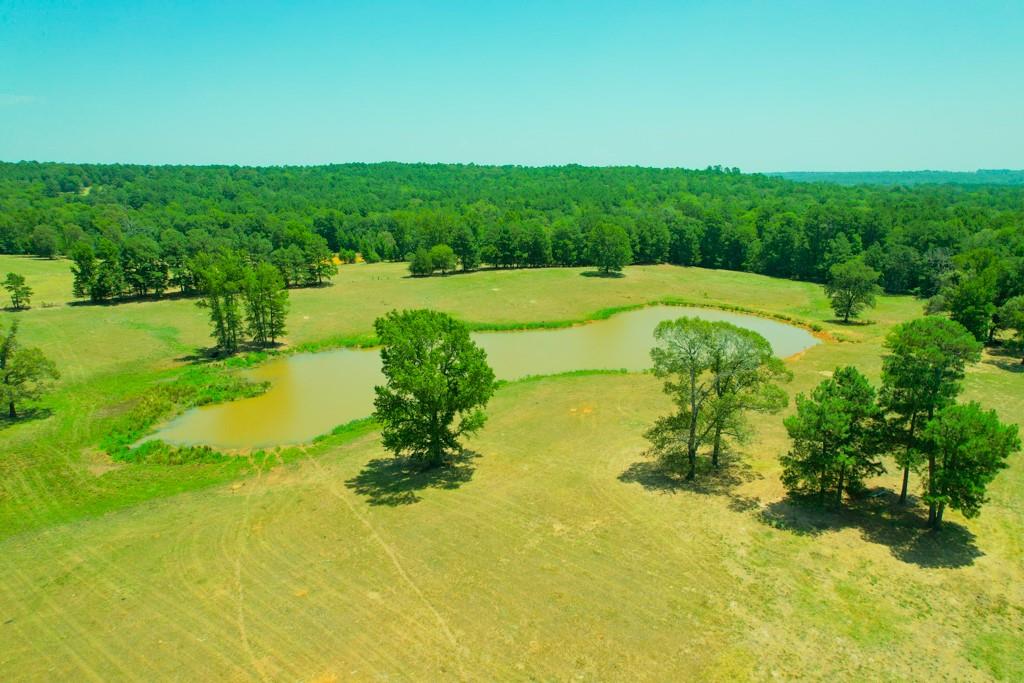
[782, 316, 1020, 527]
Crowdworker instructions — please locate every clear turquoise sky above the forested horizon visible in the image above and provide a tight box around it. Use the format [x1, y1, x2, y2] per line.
[0, 0, 1024, 172]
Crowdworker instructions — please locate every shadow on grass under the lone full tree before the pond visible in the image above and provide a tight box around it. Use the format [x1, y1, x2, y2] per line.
[345, 450, 480, 507]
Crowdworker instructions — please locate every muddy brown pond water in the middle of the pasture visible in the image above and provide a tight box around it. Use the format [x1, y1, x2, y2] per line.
[151, 306, 818, 449]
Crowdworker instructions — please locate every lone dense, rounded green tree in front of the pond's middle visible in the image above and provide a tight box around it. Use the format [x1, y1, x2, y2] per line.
[374, 310, 495, 469]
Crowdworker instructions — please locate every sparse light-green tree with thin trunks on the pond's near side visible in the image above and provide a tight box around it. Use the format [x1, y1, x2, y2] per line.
[646, 317, 791, 479]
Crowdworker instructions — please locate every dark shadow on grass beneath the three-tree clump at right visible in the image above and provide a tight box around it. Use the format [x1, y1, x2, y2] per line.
[758, 489, 984, 568]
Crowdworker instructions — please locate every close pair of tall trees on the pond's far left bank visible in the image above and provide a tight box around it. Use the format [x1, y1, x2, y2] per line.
[197, 252, 289, 354]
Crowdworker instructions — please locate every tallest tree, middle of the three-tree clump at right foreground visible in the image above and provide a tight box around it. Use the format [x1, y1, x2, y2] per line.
[880, 315, 981, 507]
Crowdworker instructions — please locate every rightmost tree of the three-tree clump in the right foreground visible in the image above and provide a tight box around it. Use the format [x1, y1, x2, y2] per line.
[924, 402, 1021, 528]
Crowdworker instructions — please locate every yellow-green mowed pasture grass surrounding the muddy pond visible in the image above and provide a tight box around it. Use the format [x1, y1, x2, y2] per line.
[0, 263, 1024, 680]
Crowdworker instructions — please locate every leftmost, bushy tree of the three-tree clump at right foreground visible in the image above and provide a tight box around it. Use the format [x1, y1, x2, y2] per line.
[781, 366, 884, 507]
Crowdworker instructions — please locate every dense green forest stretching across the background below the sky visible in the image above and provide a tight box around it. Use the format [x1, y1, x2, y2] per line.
[0, 162, 1024, 321]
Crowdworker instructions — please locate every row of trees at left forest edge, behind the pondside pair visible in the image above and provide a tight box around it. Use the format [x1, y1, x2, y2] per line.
[70, 228, 338, 302]
